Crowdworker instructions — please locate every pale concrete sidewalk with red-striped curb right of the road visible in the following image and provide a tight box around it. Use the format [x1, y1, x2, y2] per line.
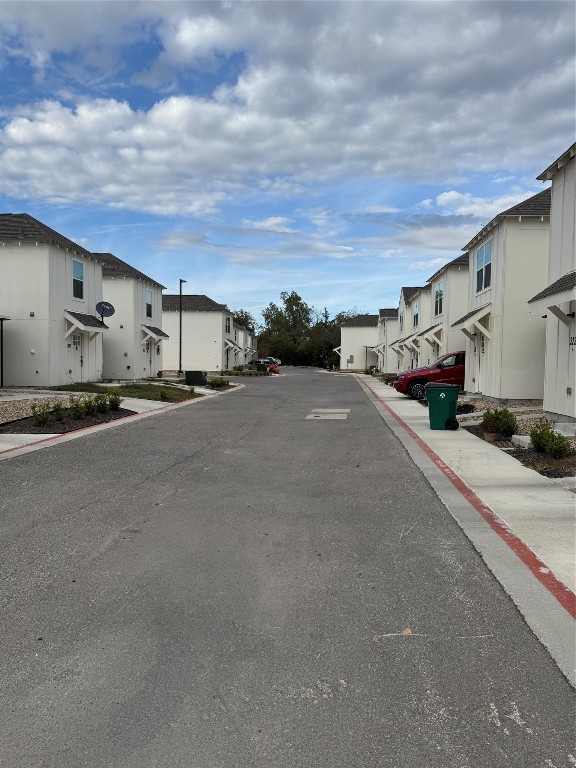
[356, 374, 576, 685]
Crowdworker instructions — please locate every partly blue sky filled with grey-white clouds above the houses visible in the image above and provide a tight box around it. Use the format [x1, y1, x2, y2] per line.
[0, 0, 575, 319]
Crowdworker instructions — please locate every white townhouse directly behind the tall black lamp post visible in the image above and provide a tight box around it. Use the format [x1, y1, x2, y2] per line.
[162, 294, 235, 373]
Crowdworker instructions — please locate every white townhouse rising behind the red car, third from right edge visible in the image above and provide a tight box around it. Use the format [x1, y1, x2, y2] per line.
[417, 253, 469, 366]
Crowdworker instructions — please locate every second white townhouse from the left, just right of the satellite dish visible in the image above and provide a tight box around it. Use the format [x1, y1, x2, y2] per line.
[94, 253, 168, 380]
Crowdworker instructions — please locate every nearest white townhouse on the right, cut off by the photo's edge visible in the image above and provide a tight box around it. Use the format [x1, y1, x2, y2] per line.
[528, 144, 576, 421]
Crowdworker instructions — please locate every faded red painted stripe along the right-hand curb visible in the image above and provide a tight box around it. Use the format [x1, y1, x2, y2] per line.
[358, 379, 576, 619]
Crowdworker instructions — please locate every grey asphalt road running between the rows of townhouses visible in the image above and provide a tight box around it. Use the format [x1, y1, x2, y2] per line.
[0, 368, 576, 768]
